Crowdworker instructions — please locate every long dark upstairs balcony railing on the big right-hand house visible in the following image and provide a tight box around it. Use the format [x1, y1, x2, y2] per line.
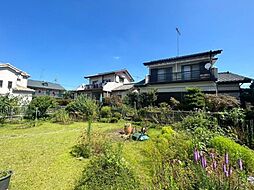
[149, 70, 215, 83]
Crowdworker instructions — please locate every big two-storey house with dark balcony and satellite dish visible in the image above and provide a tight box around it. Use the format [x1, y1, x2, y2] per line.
[135, 50, 252, 102]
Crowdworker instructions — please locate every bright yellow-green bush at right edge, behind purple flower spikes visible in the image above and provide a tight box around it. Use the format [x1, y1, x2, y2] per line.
[211, 136, 254, 172]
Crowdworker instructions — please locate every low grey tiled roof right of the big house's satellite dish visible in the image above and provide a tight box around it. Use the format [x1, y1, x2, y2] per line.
[217, 71, 253, 83]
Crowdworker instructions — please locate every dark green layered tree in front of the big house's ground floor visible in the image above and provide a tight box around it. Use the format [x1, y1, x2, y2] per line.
[184, 88, 205, 110]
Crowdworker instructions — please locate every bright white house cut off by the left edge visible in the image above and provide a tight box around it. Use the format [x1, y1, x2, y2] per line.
[0, 63, 34, 104]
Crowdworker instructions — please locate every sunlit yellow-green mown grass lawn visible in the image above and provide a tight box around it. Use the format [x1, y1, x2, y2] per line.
[0, 122, 157, 190]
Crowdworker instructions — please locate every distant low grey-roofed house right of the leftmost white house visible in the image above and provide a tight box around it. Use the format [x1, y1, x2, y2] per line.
[27, 79, 65, 98]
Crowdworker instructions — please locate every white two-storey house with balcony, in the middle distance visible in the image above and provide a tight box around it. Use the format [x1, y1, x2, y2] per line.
[77, 69, 134, 100]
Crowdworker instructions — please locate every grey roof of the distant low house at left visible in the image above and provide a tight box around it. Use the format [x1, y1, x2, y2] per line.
[27, 79, 65, 90]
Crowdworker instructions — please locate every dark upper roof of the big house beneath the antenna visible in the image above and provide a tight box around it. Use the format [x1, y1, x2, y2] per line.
[144, 50, 222, 66]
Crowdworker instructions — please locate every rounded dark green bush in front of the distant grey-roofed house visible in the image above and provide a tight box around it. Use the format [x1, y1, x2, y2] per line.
[26, 96, 57, 119]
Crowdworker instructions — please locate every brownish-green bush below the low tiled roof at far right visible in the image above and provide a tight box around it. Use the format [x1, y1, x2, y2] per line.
[205, 94, 240, 112]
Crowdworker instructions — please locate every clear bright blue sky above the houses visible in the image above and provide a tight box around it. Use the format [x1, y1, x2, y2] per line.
[0, 0, 254, 89]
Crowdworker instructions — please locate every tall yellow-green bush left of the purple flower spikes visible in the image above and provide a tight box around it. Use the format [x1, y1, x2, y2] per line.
[147, 131, 193, 189]
